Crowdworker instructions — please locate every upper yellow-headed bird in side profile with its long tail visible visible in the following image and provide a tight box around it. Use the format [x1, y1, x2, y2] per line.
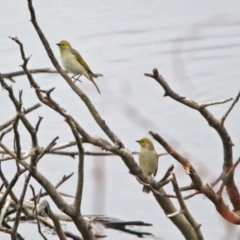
[57, 40, 103, 93]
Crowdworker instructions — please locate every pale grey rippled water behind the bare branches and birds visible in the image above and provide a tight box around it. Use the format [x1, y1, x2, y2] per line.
[0, 0, 240, 240]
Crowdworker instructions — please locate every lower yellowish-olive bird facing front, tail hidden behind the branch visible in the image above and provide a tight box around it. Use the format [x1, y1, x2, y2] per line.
[136, 138, 158, 193]
